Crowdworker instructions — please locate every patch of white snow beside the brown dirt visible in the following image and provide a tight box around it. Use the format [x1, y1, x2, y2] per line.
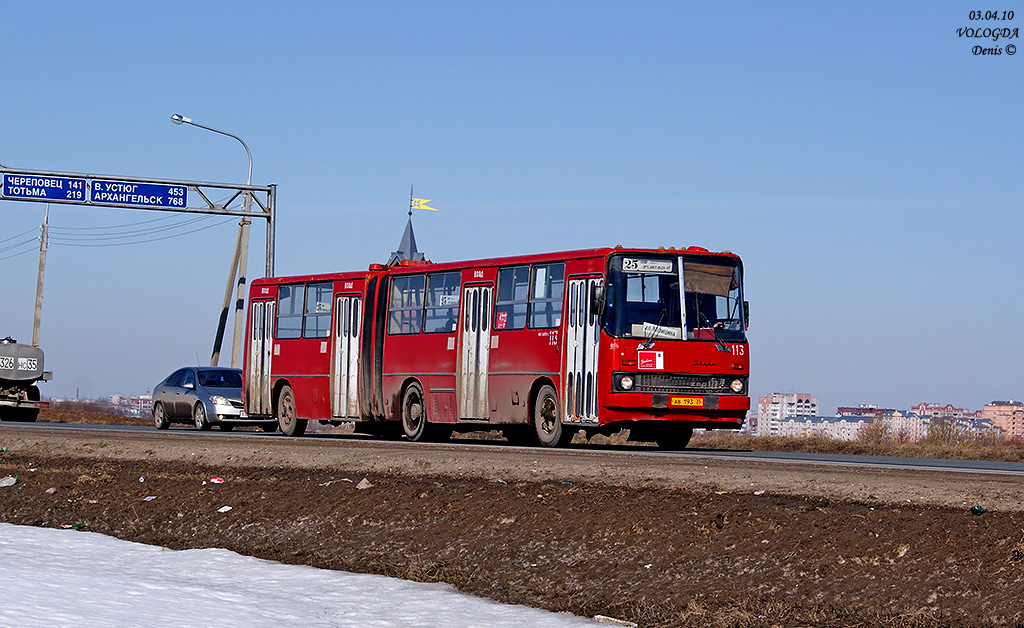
[0, 524, 599, 628]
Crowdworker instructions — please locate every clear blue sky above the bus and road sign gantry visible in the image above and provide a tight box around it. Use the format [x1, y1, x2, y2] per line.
[0, 1, 1024, 413]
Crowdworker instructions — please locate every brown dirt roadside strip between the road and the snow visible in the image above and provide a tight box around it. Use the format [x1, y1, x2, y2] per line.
[0, 413, 1024, 627]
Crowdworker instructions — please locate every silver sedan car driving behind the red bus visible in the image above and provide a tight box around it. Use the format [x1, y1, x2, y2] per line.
[153, 367, 276, 431]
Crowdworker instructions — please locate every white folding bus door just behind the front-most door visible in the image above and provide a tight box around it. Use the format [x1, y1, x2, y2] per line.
[456, 284, 495, 420]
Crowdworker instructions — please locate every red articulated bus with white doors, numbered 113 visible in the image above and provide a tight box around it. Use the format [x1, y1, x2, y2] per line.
[245, 247, 751, 449]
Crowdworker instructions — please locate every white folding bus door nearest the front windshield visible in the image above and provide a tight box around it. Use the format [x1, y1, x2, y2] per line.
[562, 278, 604, 422]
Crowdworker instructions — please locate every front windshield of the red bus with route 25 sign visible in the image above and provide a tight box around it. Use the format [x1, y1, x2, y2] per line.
[605, 253, 745, 342]
